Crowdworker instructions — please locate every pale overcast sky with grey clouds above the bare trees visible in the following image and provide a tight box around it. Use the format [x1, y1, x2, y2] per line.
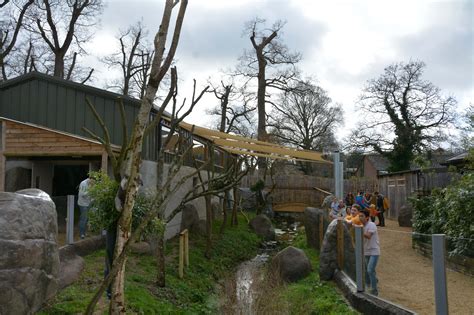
[83, 0, 474, 141]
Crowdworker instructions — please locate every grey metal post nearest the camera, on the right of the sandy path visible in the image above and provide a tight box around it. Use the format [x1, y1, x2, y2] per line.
[432, 234, 449, 315]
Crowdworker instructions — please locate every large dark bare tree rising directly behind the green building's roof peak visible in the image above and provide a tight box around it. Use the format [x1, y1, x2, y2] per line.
[23, 0, 102, 82]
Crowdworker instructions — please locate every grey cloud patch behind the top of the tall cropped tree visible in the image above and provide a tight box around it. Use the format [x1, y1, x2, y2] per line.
[180, 1, 325, 67]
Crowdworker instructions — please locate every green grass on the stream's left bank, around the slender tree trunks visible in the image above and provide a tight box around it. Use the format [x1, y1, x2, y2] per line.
[40, 218, 261, 314]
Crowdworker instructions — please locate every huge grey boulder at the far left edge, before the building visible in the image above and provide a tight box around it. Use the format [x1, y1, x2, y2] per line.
[0, 189, 59, 314]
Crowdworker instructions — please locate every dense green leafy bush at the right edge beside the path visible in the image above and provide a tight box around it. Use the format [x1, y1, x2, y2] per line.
[411, 165, 474, 257]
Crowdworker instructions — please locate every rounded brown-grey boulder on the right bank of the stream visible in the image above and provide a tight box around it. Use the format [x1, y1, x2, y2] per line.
[271, 246, 311, 282]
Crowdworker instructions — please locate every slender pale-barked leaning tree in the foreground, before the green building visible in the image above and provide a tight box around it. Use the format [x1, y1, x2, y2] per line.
[80, 0, 192, 314]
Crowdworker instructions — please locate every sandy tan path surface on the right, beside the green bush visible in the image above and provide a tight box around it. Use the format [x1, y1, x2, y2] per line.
[377, 220, 474, 315]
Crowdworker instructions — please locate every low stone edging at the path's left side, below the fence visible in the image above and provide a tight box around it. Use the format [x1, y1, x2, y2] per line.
[334, 270, 416, 315]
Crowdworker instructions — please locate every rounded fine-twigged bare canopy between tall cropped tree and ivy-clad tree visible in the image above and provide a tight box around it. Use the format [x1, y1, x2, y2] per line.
[268, 81, 343, 151]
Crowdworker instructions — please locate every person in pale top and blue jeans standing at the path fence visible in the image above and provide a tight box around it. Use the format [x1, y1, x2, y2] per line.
[359, 209, 380, 295]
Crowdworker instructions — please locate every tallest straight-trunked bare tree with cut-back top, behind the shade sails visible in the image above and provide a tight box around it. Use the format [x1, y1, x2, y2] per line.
[237, 18, 301, 169]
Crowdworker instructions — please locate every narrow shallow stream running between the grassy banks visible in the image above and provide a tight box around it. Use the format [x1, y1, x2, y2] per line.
[233, 214, 301, 314]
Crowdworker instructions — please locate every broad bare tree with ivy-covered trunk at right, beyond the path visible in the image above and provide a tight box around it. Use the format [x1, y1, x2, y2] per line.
[350, 61, 457, 171]
